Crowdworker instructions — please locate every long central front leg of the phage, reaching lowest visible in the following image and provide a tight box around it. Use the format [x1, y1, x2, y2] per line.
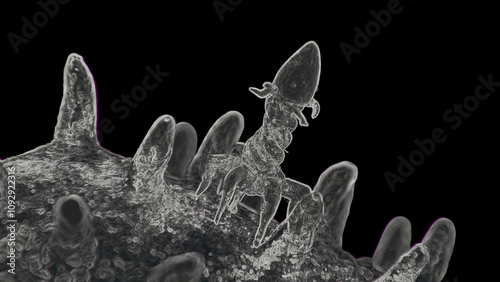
[253, 178, 281, 248]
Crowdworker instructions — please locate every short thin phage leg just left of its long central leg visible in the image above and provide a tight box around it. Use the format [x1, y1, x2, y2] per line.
[214, 166, 246, 224]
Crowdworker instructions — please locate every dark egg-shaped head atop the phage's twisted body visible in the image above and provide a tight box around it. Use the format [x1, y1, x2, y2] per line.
[273, 41, 321, 106]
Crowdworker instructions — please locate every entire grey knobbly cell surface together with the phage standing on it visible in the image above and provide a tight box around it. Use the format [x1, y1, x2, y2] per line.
[0, 41, 455, 282]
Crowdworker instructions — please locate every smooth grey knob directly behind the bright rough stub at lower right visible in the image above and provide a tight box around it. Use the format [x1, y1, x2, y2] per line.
[372, 216, 411, 272]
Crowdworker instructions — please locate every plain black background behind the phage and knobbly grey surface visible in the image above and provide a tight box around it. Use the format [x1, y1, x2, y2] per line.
[0, 0, 500, 281]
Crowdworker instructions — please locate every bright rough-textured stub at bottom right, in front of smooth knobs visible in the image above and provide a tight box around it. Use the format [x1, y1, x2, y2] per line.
[375, 244, 429, 282]
